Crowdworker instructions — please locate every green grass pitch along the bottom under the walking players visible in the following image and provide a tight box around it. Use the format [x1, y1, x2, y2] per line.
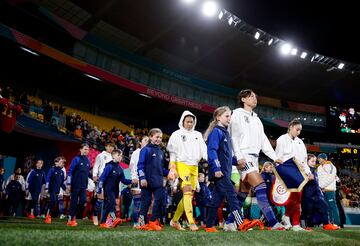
[0, 217, 360, 246]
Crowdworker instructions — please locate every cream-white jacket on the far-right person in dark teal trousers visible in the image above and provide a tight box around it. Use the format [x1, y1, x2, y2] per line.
[317, 161, 337, 191]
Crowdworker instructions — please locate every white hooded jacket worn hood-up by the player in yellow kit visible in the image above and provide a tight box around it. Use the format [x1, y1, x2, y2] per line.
[167, 110, 207, 166]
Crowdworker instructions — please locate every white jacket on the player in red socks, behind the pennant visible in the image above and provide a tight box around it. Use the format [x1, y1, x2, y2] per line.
[275, 133, 311, 174]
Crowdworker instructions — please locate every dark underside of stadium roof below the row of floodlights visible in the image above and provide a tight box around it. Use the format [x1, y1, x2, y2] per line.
[2, 0, 360, 105]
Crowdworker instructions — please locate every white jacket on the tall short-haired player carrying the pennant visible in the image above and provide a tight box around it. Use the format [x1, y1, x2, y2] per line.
[229, 108, 278, 161]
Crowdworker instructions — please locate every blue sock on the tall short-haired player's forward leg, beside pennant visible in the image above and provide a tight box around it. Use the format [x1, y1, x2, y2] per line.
[255, 182, 278, 227]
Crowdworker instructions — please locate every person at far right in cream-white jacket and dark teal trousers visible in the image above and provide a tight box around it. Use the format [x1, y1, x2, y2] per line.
[317, 153, 340, 225]
